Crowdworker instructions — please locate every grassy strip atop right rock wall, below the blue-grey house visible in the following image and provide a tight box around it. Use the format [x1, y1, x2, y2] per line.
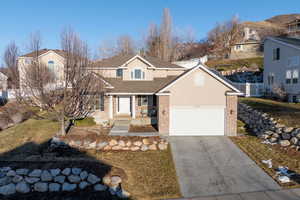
[240, 98, 300, 127]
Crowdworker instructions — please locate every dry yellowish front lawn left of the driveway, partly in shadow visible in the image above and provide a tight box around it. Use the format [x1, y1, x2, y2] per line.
[0, 116, 181, 199]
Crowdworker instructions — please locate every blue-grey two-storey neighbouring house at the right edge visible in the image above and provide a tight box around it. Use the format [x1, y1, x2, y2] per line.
[264, 37, 300, 102]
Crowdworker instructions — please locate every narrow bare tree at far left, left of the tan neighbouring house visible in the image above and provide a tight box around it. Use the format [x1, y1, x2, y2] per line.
[3, 42, 19, 88]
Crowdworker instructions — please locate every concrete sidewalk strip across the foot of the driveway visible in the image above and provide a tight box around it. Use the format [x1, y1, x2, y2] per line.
[168, 188, 300, 200]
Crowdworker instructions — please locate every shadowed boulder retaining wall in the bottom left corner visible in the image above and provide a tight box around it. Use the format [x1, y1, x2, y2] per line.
[0, 167, 130, 198]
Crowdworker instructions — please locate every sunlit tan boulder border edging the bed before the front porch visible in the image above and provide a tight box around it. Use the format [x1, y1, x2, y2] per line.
[50, 137, 168, 151]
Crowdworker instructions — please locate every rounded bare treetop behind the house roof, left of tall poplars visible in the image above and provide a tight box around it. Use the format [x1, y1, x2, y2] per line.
[117, 35, 135, 55]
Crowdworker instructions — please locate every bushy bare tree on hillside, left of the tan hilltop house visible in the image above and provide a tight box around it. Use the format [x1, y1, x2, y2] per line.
[208, 17, 242, 57]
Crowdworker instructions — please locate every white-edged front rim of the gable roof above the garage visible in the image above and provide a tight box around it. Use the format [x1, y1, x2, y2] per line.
[158, 64, 242, 94]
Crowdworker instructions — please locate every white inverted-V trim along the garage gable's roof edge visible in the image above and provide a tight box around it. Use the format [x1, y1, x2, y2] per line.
[158, 64, 241, 93]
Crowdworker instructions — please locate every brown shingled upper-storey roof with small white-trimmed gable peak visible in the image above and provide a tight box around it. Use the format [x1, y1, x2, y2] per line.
[95, 55, 184, 69]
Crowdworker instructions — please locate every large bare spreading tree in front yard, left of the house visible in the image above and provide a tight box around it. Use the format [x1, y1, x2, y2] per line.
[17, 30, 104, 135]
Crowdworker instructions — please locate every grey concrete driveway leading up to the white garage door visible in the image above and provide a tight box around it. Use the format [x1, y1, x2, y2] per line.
[169, 136, 280, 197]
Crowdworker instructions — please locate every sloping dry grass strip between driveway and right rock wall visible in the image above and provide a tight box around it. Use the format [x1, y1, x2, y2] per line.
[231, 123, 300, 188]
